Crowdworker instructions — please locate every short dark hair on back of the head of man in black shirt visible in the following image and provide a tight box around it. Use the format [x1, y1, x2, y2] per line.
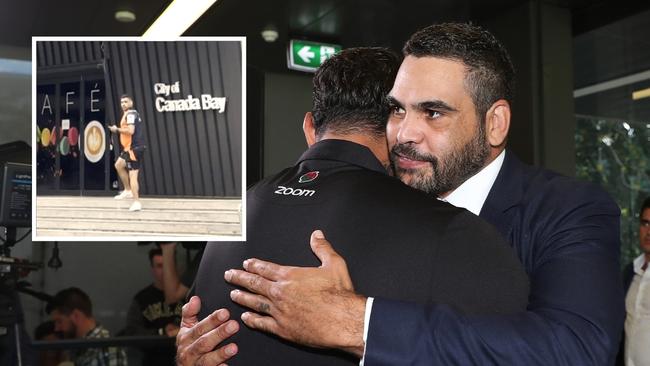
[312, 47, 400, 137]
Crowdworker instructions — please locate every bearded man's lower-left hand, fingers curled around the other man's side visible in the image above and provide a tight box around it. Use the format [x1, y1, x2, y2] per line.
[176, 296, 239, 366]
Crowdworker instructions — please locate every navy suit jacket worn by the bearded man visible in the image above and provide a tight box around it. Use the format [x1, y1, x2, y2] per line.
[365, 152, 624, 366]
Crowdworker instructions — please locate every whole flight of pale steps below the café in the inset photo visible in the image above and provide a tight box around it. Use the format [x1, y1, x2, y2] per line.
[36, 196, 243, 240]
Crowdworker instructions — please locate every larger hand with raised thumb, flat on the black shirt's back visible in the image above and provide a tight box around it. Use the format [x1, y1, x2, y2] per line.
[224, 230, 366, 357]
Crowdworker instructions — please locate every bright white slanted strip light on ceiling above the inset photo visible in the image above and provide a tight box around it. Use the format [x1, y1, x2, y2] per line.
[143, 0, 217, 38]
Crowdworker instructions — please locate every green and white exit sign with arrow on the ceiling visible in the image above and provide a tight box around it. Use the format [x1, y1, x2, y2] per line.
[287, 39, 341, 72]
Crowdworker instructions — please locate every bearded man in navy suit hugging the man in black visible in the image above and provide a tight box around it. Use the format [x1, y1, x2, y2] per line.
[220, 24, 624, 366]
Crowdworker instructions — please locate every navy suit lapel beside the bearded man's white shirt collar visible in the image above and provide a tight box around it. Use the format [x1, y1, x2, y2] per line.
[479, 151, 524, 244]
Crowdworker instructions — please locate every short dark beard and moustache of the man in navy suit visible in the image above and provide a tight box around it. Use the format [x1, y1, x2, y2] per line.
[390, 122, 490, 196]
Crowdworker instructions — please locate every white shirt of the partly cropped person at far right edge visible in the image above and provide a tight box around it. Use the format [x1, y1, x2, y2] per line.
[625, 254, 650, 366]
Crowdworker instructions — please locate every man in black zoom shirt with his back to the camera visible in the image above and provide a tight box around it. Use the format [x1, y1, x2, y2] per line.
[176, 48, 528, 366]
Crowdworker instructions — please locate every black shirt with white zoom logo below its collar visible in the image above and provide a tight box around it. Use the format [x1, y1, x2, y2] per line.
[196, 140, 528, 365]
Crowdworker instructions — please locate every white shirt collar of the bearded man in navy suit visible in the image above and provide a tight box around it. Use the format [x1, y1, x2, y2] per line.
[442, 149, 506, 215]
